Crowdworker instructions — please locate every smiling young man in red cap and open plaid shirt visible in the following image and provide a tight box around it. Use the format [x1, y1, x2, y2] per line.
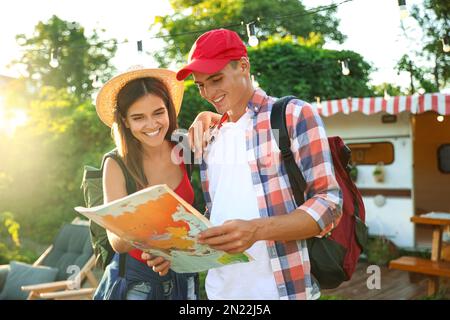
[144, 29, 342, 300]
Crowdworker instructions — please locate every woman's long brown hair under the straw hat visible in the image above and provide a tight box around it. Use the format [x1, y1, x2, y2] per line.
[111, 77, 177, 190]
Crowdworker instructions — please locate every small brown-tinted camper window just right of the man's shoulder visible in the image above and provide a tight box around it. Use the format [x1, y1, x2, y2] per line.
[348, 142, 394, 165]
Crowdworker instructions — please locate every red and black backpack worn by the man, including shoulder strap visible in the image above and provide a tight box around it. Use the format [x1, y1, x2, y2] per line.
[270, 96, 368, 289]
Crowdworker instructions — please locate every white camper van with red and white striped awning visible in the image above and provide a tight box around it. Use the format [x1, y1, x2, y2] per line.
[313, 93, 450, 249]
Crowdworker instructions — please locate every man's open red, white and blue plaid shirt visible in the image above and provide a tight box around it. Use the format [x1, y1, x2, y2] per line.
[200, 89, 342, 299]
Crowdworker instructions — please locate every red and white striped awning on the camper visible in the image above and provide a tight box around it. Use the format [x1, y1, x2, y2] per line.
[312, 93, 450, 117]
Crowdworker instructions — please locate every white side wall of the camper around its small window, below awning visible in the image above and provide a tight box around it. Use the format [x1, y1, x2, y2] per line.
[323, 112, 415, 247]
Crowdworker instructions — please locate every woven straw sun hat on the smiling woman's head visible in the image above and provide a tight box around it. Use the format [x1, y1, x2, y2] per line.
[95, 69, 184, 127]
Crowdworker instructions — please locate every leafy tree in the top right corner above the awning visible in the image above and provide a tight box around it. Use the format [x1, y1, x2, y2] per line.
[397, 0, 450, 94]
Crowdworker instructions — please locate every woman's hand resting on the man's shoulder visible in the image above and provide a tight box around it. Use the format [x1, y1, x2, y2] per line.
[189, 111, 222, 159]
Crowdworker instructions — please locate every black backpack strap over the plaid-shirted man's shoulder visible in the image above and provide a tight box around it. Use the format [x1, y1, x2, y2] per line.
[270, 96, 306, 206]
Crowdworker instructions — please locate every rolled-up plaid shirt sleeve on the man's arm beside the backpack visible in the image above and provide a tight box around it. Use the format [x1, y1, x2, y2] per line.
[286, 100, 343, 237]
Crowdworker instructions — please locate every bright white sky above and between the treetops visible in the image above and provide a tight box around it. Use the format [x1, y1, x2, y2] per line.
[0, 0, 430, 91]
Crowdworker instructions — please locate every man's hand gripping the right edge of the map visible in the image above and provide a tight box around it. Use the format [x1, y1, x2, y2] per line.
[198, 220, 259, 253]
